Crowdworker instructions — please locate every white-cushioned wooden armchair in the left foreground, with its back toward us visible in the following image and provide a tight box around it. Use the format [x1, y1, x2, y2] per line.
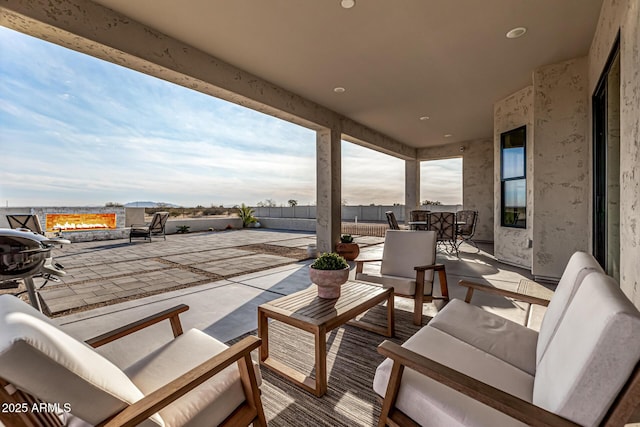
[0, 295, 266, 427]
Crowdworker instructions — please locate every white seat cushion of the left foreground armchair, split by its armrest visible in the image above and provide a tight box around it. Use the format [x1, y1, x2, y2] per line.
[125, 329, 261, 427]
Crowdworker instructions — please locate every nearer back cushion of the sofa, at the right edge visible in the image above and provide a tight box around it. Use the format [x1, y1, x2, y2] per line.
[533, 273, 640, 426]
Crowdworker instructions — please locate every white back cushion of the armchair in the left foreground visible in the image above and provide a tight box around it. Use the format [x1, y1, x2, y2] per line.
[0, 295, 164, 426]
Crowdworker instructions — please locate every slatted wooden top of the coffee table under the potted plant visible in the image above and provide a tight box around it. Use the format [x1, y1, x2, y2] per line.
[260, 280, 393, 325]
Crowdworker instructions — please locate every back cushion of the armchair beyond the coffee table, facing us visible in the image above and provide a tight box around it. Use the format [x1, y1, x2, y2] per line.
[380, 230, 436, 282]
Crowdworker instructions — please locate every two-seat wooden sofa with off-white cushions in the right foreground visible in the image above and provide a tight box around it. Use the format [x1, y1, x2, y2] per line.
[373, 252, 640, 427]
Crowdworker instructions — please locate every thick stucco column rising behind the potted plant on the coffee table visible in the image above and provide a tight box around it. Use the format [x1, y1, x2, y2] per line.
[316, 129, 342, 253]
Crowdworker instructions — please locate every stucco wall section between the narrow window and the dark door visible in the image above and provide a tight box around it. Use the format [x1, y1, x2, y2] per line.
[531, 57, 591, 278]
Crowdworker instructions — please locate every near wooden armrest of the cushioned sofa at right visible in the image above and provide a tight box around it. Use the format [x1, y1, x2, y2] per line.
[378, 340, 578, 427]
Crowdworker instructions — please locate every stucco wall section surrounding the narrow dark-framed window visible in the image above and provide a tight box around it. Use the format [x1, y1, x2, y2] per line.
[493, 86, 535, 268]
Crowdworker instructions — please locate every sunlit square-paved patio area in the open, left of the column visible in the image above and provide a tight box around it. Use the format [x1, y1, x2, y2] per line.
[40, 230, 324, 315]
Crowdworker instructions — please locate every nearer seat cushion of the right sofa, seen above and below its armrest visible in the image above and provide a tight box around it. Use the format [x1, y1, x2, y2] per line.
[373, 325, 534, 427]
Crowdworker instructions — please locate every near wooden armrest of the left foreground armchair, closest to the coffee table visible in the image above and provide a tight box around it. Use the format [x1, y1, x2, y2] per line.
[102, 336, 262, 427]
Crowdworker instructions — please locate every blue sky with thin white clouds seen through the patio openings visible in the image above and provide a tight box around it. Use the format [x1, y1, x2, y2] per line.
[0, 26, 462, 207]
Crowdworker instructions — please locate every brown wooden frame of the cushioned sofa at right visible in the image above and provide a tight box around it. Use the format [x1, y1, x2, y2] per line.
[378, 340, 640, 427]
